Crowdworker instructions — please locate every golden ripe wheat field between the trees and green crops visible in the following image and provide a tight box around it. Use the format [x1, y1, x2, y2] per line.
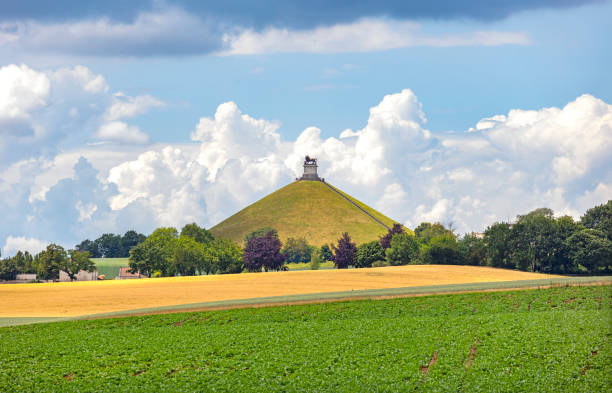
[0, 265, 559, 318]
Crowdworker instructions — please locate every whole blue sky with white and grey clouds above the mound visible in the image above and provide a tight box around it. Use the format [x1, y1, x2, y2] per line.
[0, 0, 612, 255]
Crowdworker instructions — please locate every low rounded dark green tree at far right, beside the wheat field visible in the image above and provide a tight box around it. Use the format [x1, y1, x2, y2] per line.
[567, 229, 612, 273]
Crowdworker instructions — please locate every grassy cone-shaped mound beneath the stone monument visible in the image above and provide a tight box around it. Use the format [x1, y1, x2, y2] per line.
[210, 181, 395, 246]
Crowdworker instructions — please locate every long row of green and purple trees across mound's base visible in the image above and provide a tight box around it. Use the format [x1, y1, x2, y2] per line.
[0, 200, 612, 280]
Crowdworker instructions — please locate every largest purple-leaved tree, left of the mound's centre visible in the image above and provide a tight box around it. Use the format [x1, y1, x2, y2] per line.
[242, 230, 285, 272]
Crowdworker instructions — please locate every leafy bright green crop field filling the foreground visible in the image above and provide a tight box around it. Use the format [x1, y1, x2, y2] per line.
[0, 286, 612, 392]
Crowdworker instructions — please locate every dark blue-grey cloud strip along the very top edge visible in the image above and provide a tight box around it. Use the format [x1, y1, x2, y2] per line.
[0, 0, 604, 28]
